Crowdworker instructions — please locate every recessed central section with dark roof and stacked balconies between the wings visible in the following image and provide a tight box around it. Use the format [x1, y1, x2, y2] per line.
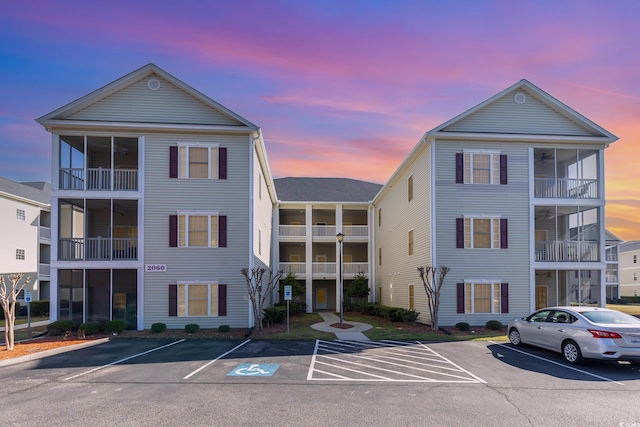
[274, 178, 382, 313]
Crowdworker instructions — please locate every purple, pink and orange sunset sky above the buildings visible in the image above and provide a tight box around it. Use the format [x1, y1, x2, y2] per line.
[0, 0, 640, 240]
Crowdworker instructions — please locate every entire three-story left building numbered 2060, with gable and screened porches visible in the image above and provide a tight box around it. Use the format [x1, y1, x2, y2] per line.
[38, 64, 275, 329]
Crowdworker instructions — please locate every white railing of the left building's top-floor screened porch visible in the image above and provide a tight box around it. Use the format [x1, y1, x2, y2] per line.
[60, 168, 138, 191]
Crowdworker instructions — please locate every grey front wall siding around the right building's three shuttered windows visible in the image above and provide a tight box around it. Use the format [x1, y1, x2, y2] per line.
[434, 141, 531, 325]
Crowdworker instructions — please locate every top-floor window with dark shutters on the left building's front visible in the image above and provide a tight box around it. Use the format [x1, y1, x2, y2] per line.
[169, 143, 227, 179]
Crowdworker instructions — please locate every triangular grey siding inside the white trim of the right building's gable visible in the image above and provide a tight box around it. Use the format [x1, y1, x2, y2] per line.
[443, 89, 600, 136]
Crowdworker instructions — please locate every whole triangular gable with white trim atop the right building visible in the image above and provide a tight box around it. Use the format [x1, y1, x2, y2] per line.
[427, 79, 618, 143]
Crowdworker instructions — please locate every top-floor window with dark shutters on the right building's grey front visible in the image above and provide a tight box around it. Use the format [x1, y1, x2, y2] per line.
[456, 150, 507, 185]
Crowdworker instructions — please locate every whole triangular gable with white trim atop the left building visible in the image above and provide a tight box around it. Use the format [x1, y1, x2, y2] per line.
[37, 64, 258, 130]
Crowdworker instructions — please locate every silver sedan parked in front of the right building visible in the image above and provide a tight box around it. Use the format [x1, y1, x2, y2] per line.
[507, 306, 640, 364]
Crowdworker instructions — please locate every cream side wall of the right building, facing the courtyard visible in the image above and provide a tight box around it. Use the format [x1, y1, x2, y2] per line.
[371, 145, 431, 322]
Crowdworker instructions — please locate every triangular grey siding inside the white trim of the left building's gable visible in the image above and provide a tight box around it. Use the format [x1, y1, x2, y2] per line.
[62, 74, 242, 126]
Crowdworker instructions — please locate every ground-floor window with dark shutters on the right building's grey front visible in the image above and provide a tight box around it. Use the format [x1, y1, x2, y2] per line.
[458, 280, 509, 314]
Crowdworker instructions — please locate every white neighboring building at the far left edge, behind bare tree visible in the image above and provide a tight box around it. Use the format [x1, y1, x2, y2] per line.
[0, 177, 51, 305]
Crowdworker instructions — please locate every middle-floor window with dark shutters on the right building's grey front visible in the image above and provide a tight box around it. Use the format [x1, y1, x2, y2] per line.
[456, 216, 508, 249]
